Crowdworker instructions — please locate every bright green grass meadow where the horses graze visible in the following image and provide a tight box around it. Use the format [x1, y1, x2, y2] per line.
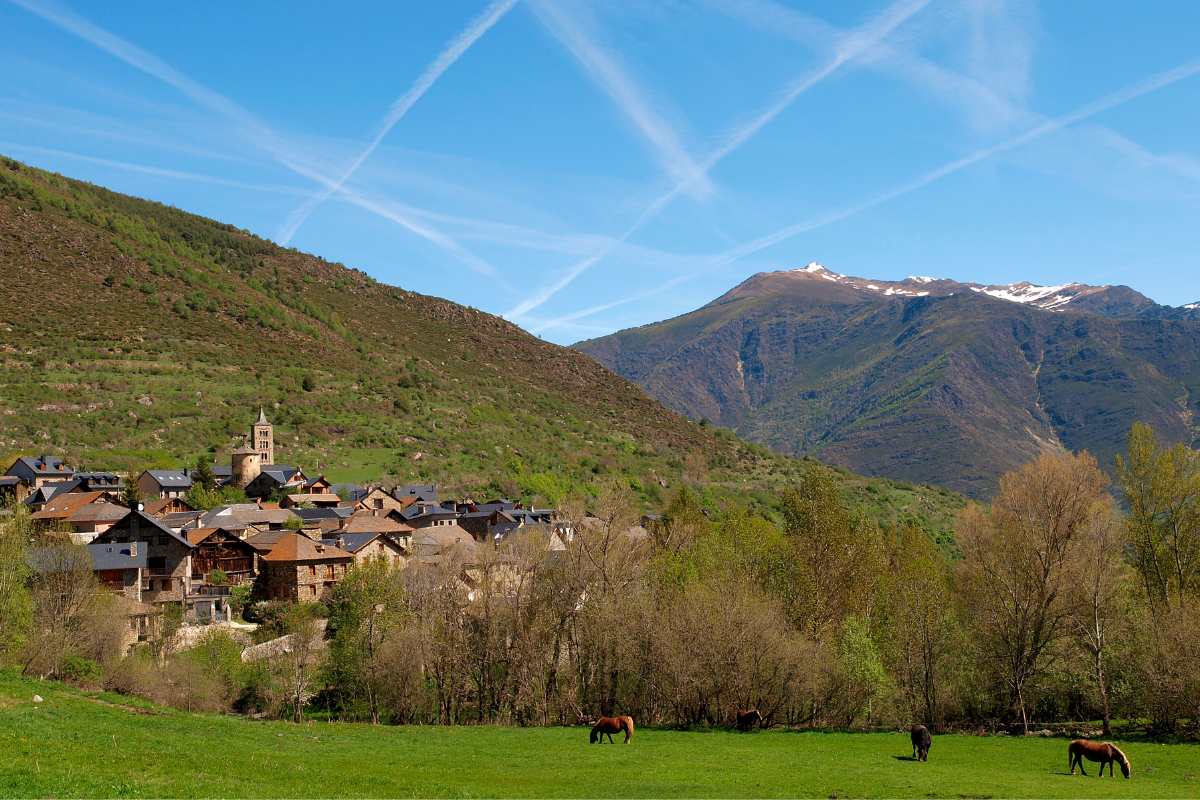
[0, 673, 1200, 798]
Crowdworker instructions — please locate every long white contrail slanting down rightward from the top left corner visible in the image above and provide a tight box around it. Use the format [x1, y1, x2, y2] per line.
[12, 0, 496, 284]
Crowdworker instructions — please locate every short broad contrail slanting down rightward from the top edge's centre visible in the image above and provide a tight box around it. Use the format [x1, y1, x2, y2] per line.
[530, 0, 713, 198]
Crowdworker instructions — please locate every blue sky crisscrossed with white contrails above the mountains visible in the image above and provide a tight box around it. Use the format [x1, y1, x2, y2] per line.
[0, 0, 1200, 343]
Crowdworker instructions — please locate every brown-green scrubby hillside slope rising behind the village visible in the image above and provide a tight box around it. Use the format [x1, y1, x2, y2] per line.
[0, 160, 960, 529]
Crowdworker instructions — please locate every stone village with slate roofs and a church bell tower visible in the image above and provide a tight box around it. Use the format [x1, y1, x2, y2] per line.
[0, 409, 571, 652]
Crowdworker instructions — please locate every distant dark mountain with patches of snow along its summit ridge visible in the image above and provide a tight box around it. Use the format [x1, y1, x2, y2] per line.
[575, 263, 1200, 497]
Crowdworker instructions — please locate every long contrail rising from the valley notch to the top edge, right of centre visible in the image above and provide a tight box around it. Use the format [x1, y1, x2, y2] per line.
[504, 0, 930, 319]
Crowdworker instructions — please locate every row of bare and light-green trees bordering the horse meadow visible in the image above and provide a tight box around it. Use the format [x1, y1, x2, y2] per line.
[0, 426, 1200, 733]
